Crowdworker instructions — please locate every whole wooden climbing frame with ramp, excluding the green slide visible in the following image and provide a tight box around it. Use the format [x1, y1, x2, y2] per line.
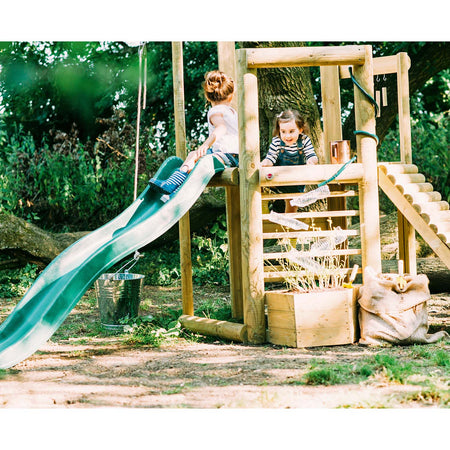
[172, 42, 450, 344]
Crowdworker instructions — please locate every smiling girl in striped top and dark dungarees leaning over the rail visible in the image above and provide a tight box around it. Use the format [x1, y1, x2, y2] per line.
[261, 110, 319, 213]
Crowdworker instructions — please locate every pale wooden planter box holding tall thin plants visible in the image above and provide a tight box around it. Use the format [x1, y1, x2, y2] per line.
[265, 287, 359, 347]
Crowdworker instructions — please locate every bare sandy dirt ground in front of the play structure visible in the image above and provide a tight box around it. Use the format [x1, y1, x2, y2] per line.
[0, 286, 450, 409]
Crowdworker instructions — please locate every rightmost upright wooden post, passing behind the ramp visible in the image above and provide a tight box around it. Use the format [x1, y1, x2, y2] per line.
[397, 52, 417, 275]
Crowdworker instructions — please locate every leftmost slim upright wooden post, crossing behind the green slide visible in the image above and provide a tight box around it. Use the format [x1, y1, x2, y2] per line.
[172, 42, 194, 315]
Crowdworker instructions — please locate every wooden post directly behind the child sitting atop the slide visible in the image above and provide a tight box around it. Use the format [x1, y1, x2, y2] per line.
[217, 42, 244, 319]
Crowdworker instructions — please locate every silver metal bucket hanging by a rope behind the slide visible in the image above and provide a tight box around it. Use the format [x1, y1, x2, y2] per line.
[95, 272, 145, 330]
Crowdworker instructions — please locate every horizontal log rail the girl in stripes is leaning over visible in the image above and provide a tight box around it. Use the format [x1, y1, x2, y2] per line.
[260, 163, 363, 186]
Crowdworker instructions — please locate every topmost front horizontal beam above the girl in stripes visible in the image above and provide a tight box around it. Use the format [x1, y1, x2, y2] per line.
[246, 45, 367, 69]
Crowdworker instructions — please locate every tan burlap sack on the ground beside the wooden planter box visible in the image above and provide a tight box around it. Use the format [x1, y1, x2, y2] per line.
[358, 267, 449, 345]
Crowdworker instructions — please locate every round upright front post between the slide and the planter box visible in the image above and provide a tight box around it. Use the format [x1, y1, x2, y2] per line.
[237, 50, 266, 344]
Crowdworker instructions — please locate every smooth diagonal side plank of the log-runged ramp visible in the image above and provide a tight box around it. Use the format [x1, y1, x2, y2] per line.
[378, 171, 450, 268]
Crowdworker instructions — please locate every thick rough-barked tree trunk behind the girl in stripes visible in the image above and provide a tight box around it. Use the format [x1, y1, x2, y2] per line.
[240, 42, 323, 161]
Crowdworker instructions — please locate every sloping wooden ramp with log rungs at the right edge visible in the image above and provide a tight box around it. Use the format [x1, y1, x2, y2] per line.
[378, 163, 450, 269]
